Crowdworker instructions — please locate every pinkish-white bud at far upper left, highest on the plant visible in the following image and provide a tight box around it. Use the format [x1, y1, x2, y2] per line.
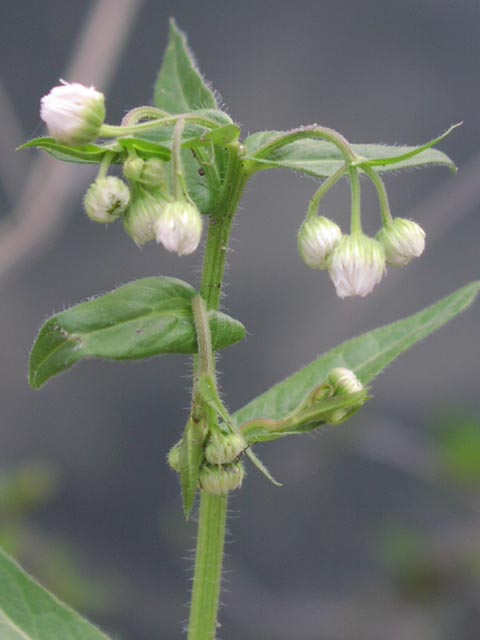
[40, 82, 105, 146]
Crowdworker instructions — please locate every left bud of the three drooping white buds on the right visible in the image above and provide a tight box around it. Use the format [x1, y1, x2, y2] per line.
[298, 216, 342, 269]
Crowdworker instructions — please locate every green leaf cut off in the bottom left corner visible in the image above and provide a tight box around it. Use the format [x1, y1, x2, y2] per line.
[0, 549, 108, 640]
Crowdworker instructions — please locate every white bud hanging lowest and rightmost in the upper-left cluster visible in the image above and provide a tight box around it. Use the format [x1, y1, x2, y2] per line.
[155, 201, 202, 256]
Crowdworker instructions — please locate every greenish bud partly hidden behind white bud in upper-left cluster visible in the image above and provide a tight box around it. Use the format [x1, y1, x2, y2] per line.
[123, 188, 167, 246]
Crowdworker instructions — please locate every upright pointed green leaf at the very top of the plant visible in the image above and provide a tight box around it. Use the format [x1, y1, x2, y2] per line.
[154, 20, 218, 113]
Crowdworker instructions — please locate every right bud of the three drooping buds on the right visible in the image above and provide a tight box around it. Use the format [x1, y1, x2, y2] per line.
[377, 218, 425, 267]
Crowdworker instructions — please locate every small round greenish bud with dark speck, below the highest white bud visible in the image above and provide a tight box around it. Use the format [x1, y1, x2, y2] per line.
[83, 176, 130, 223]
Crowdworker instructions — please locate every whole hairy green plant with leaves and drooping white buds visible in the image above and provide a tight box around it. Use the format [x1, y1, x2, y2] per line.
[0, 17, 480, 640]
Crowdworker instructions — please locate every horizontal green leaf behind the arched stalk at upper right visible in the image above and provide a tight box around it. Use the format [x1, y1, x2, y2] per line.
[244, 125, 458, 178]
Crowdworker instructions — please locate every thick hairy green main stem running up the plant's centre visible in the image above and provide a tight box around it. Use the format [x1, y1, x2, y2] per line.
[188, 146, 247, 640]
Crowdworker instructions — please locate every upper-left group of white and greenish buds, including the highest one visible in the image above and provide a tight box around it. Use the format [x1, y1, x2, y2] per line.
[40, 82, 203, 256]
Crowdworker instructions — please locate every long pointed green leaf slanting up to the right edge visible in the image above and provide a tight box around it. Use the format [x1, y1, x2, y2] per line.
[234, 281, 480, 425]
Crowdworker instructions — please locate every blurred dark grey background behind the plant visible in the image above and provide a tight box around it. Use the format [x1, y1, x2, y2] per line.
[0, 0, 480, 640]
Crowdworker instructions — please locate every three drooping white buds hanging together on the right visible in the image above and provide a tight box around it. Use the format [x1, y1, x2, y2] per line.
[298, 216, 425, 298]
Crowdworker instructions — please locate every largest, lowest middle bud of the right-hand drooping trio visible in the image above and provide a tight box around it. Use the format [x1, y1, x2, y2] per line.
[328, 235, 385, 298]
